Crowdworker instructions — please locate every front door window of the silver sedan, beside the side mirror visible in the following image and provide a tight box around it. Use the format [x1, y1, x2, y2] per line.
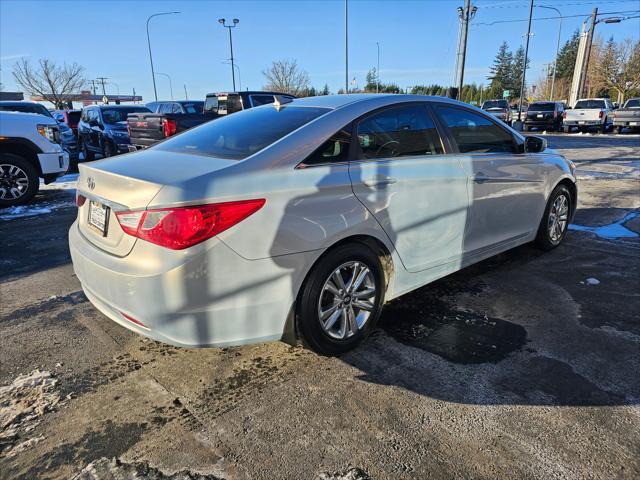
[436, 105, 515, 153]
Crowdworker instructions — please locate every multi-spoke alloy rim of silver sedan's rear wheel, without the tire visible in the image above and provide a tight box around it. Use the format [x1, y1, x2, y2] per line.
[318, 261, 376, 340]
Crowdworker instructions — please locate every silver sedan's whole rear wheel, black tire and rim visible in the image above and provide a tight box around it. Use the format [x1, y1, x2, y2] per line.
[296, 243, 385, 355]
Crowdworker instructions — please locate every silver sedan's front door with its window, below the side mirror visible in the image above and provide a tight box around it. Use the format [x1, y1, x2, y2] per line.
[434, 103, 545, 255]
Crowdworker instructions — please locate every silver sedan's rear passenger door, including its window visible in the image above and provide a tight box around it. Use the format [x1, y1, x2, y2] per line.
[349, 102, 468, 272]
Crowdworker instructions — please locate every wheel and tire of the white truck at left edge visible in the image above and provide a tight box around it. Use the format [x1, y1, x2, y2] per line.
[0, 153, 40, 208]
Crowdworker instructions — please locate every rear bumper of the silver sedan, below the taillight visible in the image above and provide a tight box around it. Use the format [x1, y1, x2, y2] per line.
[69, 222, 309, 347]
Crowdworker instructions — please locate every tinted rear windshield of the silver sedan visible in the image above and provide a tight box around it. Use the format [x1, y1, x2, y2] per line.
[154, 105, 329, 160]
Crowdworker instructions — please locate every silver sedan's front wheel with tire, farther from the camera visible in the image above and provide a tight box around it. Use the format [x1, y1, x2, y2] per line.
[535, 185, 573, 250]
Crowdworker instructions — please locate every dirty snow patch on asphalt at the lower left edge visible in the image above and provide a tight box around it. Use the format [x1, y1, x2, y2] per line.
[0, 370, 60, 455]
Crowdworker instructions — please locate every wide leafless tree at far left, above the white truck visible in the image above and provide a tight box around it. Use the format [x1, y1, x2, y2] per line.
[13, 58, 87, 108]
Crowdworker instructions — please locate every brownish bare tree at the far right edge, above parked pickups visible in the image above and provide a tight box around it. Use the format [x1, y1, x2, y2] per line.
[594, 39, 640, 102]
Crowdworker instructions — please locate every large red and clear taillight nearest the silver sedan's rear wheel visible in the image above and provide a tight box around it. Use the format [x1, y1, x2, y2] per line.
[116, 198, 266, 250]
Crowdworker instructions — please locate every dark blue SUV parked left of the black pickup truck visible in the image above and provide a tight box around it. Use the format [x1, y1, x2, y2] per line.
[78, 105, 151, 161]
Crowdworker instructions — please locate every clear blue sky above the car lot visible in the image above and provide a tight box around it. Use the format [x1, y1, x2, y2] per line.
[0, 0, 640, 101]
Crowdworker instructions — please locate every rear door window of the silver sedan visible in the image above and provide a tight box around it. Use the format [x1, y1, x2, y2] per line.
[357, 105, 444, 159]
